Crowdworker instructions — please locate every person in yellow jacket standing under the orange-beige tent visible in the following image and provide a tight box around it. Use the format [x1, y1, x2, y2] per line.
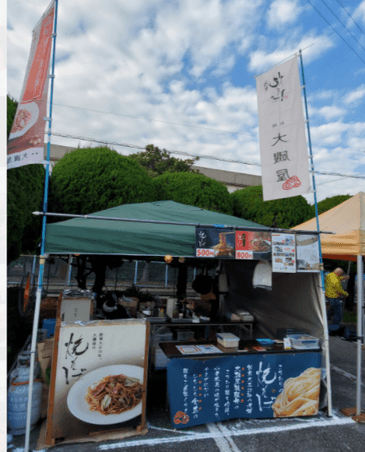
[325, 268, 349, 331]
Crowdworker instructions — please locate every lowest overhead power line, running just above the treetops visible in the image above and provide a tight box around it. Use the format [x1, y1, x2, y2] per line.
[51, 132, 365, 179]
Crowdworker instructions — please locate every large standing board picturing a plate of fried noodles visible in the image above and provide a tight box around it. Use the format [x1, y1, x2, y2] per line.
[47, 319, 148, 440]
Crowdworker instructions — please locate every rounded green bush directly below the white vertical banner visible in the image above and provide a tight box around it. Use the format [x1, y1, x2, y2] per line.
[231, 185, 313, 229]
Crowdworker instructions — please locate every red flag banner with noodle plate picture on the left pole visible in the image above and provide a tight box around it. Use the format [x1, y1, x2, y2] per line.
[7, 1, 55, 169]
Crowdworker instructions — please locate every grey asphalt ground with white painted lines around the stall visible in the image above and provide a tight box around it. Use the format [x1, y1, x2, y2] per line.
[7, 337, 365, 452]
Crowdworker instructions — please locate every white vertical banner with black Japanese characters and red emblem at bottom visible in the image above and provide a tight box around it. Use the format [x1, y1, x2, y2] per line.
[256, 56, 311, 201]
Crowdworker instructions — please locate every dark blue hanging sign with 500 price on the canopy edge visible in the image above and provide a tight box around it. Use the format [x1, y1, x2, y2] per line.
[195, 227, 235, 259]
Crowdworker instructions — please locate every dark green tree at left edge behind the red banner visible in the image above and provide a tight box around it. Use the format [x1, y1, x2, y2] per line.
[7, 96, 45, 262]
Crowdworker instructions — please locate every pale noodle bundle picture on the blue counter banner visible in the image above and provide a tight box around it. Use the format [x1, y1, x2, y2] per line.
[272, 367, 321, 417]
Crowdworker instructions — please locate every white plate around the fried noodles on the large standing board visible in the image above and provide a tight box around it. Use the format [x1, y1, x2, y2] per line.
[67, 364, 144, 425]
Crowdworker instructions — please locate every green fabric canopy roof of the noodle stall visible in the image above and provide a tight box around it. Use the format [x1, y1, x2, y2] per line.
[45, 201, 266, 257]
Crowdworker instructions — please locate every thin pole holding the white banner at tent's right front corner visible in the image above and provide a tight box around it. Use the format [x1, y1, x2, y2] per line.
[299, 50, 332, 417]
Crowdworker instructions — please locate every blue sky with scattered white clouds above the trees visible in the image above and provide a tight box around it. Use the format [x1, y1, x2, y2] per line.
[7, 0, 365, 202]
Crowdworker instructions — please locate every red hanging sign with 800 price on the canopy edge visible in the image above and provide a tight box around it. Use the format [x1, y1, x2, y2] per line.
[235, 231, 271, 260]
